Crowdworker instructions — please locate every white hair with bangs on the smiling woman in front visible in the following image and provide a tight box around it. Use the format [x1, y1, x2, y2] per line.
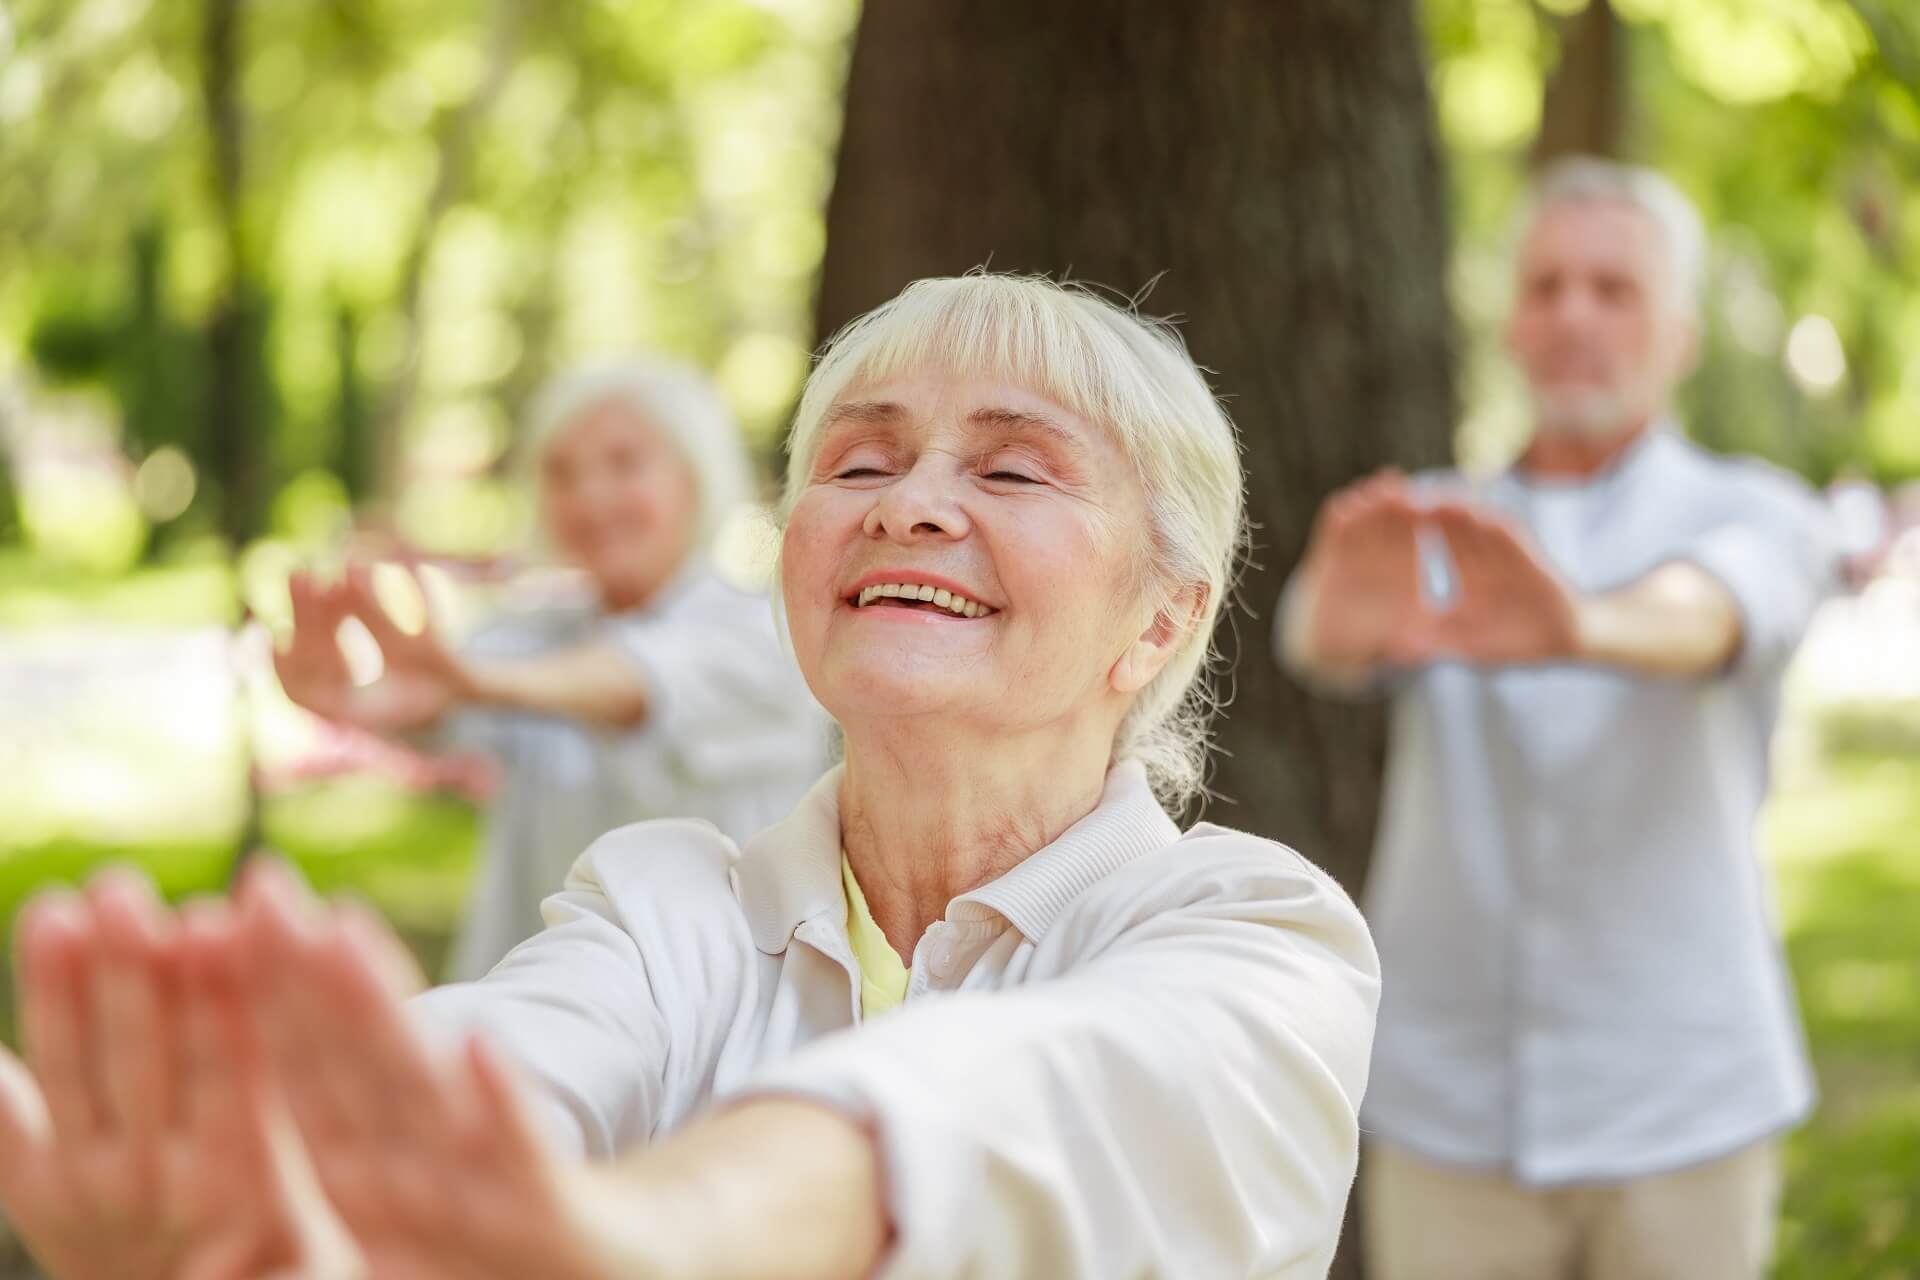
[781, 273, 1244, 804]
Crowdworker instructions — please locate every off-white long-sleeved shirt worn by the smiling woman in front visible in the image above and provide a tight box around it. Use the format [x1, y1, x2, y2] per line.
[420, 764, 1379, 1280]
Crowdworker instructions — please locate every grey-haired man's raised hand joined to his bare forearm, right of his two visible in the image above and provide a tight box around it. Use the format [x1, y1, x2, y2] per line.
[1392, 501, 1580, 666]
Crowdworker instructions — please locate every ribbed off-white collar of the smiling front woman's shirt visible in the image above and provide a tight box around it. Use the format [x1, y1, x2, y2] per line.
[733, 760, 1181, 956]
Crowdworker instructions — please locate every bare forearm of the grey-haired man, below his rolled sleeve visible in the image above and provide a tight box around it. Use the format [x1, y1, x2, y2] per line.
[1576, 562, 1741, 677]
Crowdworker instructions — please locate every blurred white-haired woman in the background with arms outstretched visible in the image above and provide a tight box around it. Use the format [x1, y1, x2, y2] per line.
[276, 363, 828, 979]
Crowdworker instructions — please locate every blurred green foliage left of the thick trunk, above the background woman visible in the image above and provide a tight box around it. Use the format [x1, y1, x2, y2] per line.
[0, 0, 854, 560]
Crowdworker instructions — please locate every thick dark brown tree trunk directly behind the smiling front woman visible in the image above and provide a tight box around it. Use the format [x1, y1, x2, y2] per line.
[818, 0, 1455, 1274]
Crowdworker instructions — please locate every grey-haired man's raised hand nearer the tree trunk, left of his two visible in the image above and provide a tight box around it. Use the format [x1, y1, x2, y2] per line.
[1308, 472, 1421, 668]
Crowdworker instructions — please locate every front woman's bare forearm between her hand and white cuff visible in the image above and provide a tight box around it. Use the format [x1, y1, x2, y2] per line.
[580, 1098, 889, 1280]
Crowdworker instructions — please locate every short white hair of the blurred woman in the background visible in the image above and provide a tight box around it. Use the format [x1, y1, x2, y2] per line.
[524, 359, 753, 553]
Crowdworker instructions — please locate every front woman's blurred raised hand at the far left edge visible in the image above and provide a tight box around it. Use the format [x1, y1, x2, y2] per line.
[0, 873, 359, 1280]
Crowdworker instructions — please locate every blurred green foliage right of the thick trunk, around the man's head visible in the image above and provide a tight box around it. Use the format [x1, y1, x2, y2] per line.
[1423, 0, 1920, 482]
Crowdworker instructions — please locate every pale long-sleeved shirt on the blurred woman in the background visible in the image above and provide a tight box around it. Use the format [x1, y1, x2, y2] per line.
[438, 564, 829, 979]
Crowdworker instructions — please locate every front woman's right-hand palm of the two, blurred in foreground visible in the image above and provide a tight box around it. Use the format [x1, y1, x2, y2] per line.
[240, 864, 622, 1280]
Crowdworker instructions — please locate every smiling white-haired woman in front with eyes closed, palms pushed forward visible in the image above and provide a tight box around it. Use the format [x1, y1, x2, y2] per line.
[0, 276, 1379, 1280]
